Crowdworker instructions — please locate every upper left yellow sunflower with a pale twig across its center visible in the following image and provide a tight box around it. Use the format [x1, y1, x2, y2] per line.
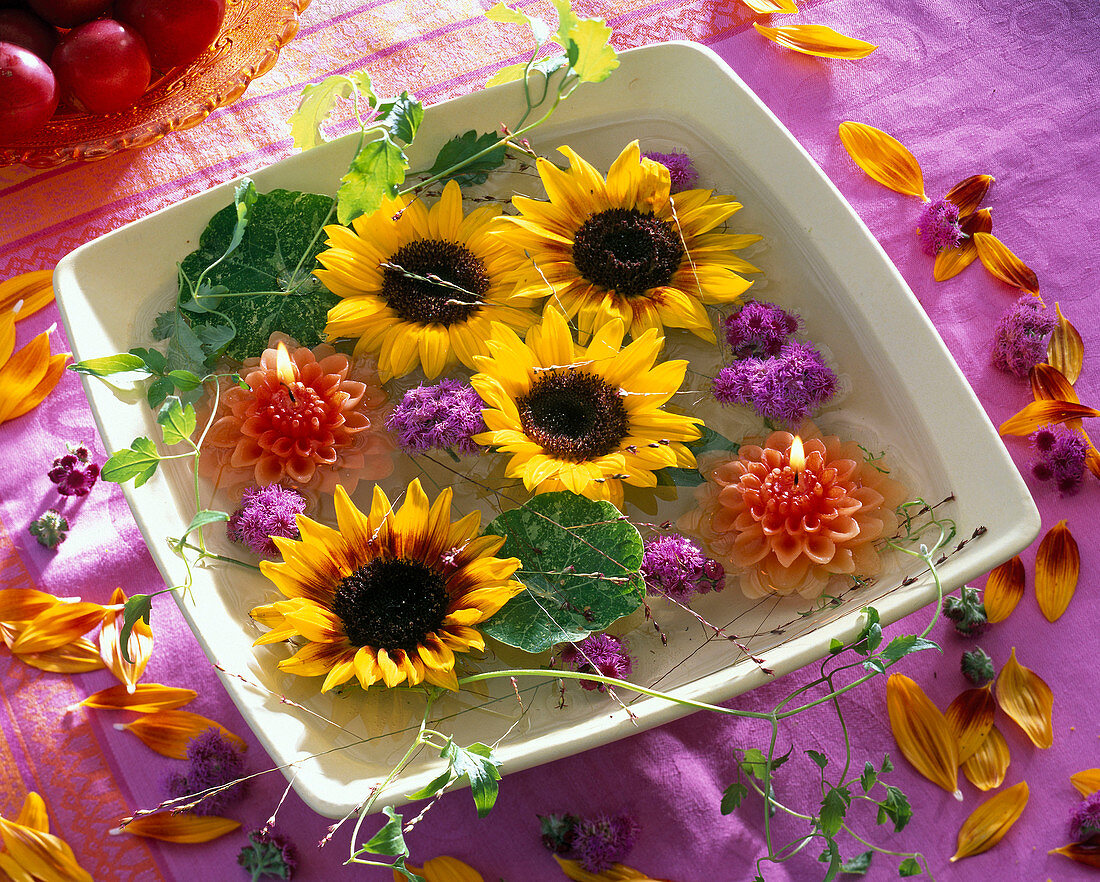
[315, 180, 536, 382]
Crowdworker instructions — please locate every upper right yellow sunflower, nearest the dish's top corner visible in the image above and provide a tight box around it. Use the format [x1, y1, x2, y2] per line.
[497, 141, 760, 342]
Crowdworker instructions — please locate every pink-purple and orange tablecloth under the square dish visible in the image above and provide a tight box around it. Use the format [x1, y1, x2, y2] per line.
[0, 0, 1100, 882]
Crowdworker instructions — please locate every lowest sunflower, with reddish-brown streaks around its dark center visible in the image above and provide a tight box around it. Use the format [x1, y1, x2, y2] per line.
[251, 481, 523, 692]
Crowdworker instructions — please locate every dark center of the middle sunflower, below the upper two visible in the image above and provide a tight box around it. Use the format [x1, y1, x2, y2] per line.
[516, 371, 628, 462]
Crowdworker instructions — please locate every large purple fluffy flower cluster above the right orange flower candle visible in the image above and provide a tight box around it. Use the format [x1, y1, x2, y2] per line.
[714, 341, 837, 426]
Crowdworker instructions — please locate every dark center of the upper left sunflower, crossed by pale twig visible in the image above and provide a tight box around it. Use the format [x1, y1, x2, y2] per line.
[382, 239, 490, 326]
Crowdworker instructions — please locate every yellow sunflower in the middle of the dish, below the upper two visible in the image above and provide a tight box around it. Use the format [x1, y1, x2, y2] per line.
[470, 308, 703, 505]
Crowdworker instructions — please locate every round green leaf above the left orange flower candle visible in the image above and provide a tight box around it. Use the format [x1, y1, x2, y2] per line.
[183, 190, 340, 361]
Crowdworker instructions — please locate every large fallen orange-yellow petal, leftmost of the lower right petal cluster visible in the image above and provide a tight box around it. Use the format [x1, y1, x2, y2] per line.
[887, 674, 961, 798]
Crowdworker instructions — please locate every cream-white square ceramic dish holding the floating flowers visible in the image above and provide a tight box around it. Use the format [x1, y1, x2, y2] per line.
[55, 43, 1040, 817]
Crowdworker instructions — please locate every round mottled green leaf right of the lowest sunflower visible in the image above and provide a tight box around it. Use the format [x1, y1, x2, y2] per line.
[480, 490, 646, 652]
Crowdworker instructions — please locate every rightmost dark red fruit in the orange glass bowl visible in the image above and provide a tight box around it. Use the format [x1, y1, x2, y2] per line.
[114, 0, 226, 70]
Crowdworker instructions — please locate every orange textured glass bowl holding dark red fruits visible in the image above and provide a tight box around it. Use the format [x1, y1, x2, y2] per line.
[0, 0, 310, 168]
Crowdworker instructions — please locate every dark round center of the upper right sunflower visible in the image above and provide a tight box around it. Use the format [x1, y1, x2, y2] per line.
[573, 208, 684, 297]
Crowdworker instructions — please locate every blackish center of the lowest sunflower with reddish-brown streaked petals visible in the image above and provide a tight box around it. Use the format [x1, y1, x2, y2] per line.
[332, 558, 448, 652]
